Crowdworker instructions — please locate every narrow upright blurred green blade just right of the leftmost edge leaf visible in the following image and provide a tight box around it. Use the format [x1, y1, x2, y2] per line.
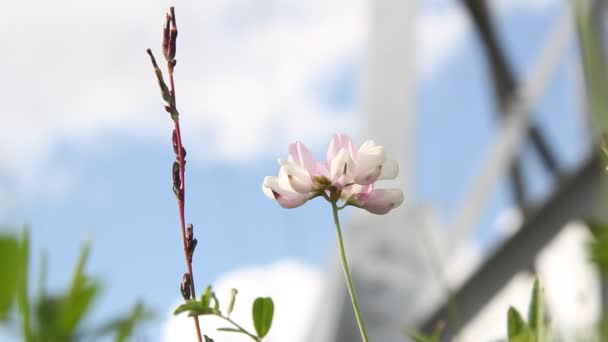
[16, 226, 33, 342]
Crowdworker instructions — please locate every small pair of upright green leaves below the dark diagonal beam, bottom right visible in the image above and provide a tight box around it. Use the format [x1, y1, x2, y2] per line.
[507, 279, 548, 342]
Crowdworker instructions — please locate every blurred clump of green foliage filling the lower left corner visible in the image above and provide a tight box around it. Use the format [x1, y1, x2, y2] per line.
[0, 228, 150, 342]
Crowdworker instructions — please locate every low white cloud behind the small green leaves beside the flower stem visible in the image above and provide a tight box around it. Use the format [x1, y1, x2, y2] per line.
[163, 261, 322, 342]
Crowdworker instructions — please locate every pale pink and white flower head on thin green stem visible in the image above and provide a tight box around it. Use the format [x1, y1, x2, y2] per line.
[262, 134, 403, 215]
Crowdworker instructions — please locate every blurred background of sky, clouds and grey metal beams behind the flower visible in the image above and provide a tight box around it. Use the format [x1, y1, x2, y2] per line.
[0, 0, 606, 342]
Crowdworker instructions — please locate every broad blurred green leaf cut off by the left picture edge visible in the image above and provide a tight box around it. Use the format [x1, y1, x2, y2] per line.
[0, 236, 19, 321]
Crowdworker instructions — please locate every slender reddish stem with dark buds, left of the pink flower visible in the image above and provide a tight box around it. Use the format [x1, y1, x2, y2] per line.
[147, 7, 203, 342]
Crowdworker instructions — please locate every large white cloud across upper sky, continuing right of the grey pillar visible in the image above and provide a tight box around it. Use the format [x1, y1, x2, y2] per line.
[0, 0, 560, 206]
